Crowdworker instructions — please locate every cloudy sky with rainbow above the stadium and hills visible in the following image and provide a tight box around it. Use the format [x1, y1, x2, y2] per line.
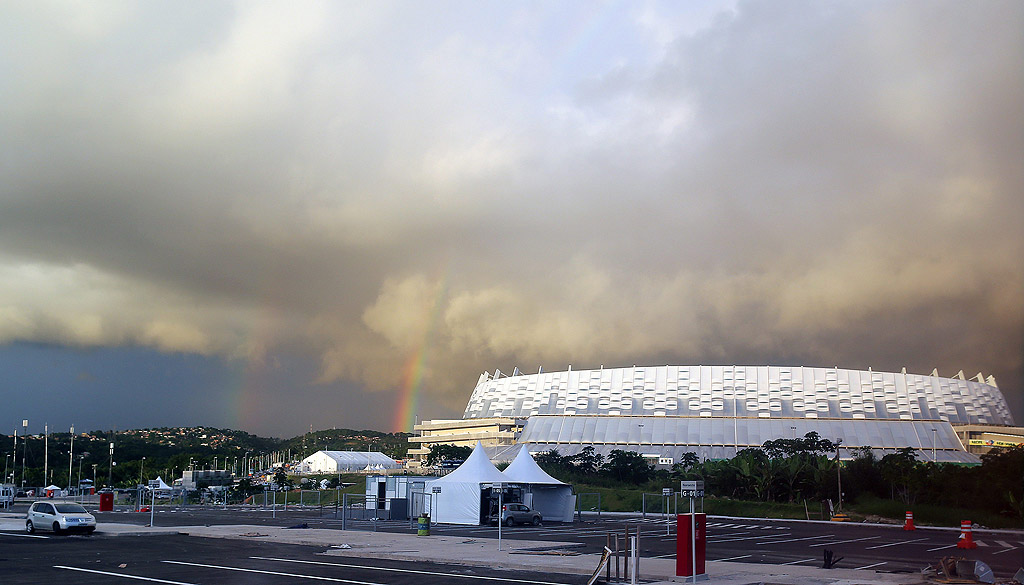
[0, 0, 1024, 435]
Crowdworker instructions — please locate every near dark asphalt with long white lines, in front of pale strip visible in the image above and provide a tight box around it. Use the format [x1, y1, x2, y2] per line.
[0, 534, 586, 585]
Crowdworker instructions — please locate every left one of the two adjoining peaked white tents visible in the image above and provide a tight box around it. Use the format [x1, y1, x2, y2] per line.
[424, 442, 517, 526]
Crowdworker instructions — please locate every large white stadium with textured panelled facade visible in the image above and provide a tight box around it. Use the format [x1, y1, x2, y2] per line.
[410, 366, 1024, 465]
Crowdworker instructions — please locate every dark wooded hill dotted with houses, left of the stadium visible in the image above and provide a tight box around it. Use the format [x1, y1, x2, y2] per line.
[0, 426, 411, 487]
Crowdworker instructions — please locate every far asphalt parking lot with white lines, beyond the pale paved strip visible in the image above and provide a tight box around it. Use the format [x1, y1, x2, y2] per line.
[0, 505, 1024, 582]
